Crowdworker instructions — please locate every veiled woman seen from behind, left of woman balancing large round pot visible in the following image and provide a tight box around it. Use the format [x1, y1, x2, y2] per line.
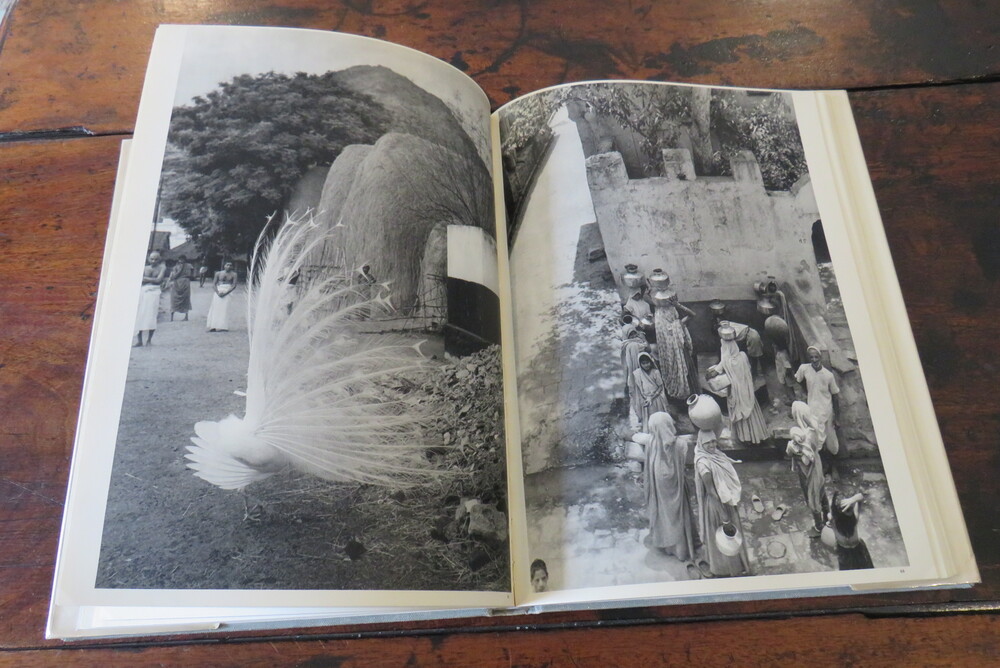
[645, 413, 694, 561]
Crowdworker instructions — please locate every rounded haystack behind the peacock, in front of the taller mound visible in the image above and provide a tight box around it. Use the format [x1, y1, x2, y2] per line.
[332, 133, 493, 309]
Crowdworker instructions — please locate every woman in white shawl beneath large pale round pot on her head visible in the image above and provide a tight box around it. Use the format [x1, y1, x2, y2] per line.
[694, 429, 750, 577]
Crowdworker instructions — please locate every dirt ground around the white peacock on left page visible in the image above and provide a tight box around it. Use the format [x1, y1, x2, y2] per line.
[97, 282, 509, 591]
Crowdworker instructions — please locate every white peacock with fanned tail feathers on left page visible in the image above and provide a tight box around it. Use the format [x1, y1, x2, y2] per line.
[187, 215, 450, 489]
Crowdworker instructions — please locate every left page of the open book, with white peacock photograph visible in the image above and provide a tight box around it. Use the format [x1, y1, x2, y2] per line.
[54, 26, 511, 628]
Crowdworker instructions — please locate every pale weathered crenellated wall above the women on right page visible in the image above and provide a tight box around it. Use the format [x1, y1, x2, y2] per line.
[587, 148, 824, 304]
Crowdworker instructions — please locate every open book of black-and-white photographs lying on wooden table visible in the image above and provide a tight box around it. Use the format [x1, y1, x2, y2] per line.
[47, 26, 978, 638]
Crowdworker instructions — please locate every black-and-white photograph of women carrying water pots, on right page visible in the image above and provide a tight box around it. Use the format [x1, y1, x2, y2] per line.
[499, 82, 909, 592]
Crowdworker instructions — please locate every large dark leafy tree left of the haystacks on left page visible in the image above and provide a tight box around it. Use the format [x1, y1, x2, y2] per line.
[161, 72, 390, 253]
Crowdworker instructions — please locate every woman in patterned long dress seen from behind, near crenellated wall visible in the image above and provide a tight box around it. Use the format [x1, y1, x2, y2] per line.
[653, 291, 698, 399]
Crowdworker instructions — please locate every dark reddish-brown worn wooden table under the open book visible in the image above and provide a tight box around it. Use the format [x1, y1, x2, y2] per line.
[0, 0, 1000, 666]
